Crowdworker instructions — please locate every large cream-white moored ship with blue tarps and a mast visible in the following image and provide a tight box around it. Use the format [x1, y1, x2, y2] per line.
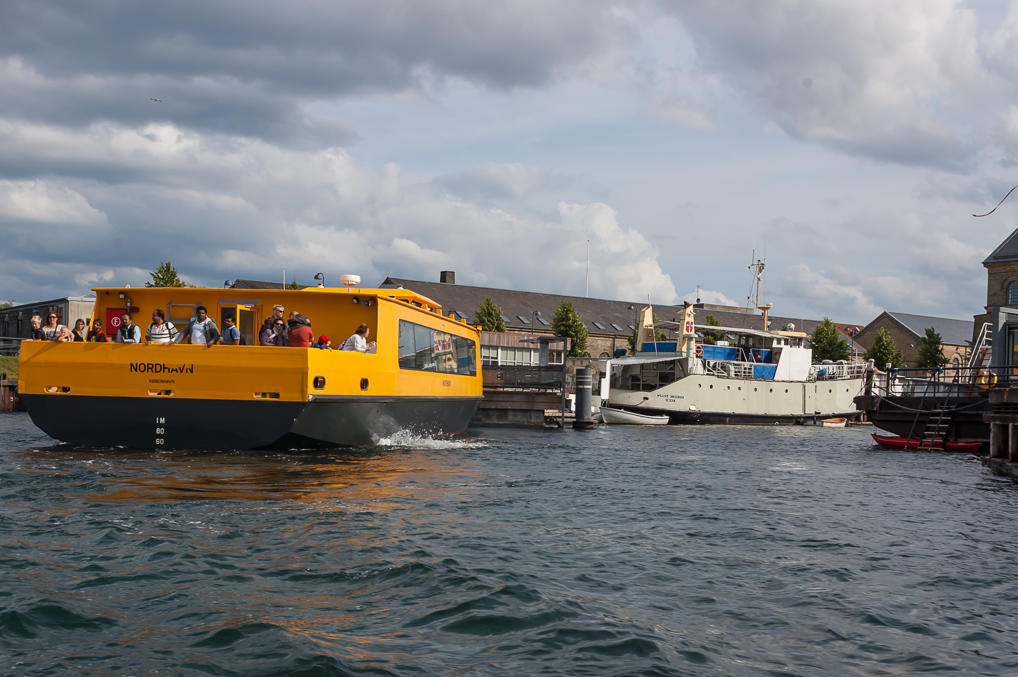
[606, 262, 866, 425]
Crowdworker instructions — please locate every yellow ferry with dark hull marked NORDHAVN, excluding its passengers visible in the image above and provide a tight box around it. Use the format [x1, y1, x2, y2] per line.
[18, 280, 482, 449]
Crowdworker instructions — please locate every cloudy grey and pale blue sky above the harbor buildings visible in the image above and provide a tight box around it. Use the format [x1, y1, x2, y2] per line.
[0, 0, 1018, 323]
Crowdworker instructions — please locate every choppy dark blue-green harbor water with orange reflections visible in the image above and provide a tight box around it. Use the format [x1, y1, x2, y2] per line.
[0, 414, 1018, 675]
